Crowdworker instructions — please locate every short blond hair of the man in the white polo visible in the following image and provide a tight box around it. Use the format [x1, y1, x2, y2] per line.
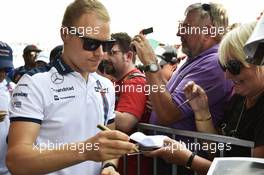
[62, 0, 110, 27]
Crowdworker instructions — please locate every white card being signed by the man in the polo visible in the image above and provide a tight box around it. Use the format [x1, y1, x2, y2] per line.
[130, 132, 168, 148]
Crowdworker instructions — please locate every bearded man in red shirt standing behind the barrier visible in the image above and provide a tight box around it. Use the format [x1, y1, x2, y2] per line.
[104, 33, 151, 175]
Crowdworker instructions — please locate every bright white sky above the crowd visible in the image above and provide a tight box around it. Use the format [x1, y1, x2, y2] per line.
[0, 0, 264, 67]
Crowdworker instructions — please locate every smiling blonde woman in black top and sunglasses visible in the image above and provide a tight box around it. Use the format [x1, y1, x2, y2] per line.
[150, 22, 264, 174]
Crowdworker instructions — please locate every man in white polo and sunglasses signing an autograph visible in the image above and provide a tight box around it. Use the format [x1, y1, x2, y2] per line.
[7, 0, 135, 175]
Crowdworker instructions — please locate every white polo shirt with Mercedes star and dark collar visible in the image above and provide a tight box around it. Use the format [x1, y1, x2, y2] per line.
[10, 58, 115, 175]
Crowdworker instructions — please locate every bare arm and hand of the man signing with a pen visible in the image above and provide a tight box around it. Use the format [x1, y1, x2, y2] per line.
[7, 121, 135, 175]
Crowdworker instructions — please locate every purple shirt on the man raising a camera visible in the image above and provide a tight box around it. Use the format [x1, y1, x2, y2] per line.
[150, 44, 233, 131]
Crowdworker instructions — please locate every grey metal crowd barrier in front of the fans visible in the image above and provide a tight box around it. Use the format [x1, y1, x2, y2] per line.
[123, 123, 254, 175]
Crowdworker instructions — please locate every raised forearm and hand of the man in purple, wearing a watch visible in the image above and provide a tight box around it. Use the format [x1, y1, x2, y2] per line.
[132, 34, 184, 125]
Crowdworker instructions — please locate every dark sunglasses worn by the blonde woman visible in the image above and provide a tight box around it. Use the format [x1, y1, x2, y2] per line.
[218, 59, 244, 75]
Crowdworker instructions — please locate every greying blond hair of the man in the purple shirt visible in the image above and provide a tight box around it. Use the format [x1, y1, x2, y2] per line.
[185, 2, 228, 42]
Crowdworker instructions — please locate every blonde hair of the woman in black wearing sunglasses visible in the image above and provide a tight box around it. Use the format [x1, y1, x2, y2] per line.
[218, 21, 257, 66]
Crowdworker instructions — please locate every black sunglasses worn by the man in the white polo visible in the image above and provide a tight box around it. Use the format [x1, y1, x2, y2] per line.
[76, 32, 116, 52]
